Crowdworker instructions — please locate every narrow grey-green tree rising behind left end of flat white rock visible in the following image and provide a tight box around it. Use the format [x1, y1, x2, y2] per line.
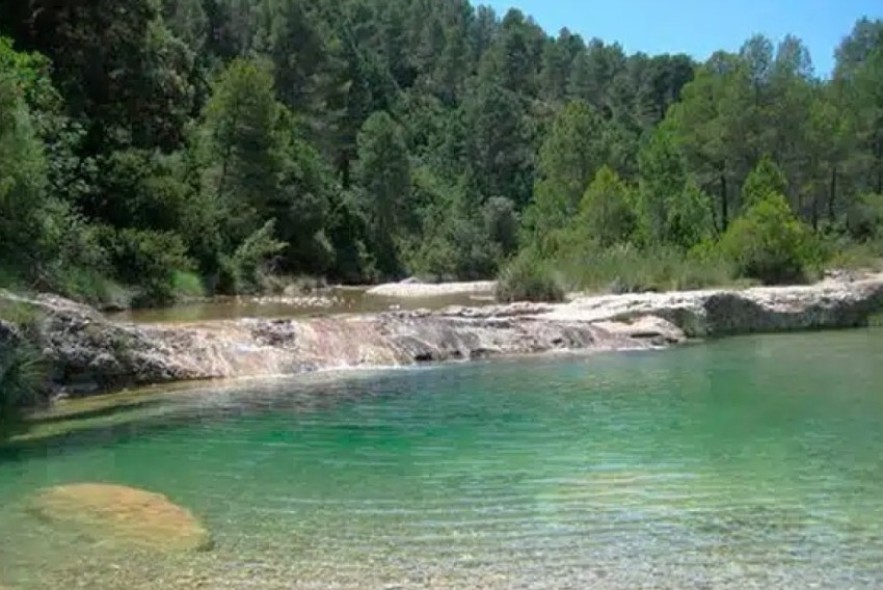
[356, 112, 411, 277]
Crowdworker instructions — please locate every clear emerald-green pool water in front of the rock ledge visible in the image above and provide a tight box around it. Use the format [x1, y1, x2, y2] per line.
[0, 330, 883, 590]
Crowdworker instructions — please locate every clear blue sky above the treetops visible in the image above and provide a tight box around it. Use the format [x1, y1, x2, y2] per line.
[486, 0, 883, 75]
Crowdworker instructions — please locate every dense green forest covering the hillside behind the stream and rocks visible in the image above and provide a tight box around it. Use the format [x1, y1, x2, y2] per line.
[0, 0, 883, 305]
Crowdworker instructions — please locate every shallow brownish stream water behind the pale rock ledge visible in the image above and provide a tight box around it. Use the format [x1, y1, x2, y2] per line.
[109, 287, 494, 323]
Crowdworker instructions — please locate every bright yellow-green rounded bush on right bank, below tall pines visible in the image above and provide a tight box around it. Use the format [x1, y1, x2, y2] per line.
[721, 193, 821, 284]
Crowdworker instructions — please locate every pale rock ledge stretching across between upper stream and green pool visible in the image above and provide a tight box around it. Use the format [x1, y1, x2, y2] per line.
[0, 274, 883, 394]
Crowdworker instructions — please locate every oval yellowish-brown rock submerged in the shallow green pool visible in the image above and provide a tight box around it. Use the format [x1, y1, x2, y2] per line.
[32, 483, 212, 551]
